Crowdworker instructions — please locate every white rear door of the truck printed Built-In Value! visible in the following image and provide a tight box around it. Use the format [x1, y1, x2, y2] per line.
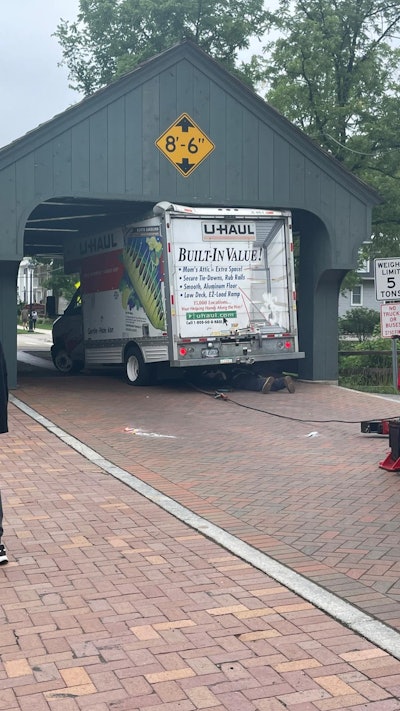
[169, 219, 290, 338]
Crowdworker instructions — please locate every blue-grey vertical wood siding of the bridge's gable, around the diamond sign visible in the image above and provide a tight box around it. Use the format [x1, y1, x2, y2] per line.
[0, 48, 378, 268]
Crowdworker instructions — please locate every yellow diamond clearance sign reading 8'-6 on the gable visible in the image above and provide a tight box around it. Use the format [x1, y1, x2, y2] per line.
[156, 114, 215, 178]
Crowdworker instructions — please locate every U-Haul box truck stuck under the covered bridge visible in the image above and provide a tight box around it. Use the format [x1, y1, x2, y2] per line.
[52, 202, 304, 385]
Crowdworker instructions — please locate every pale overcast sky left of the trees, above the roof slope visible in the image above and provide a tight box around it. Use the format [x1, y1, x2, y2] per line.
[0, 0, 83, 147]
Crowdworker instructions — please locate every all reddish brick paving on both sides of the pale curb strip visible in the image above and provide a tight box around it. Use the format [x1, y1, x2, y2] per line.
[0, 358, 400, 711]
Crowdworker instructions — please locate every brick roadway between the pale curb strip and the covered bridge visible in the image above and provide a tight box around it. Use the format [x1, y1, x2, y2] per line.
[10, 371, 400, 629]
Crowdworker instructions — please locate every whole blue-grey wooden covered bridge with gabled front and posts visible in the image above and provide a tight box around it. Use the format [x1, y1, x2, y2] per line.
[0, 42, 379, 387]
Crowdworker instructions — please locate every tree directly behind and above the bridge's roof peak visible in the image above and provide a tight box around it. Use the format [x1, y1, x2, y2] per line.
[55, 0, 266, 95]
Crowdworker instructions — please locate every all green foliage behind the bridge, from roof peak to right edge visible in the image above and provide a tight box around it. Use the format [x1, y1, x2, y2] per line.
[55, 0, 400, 278]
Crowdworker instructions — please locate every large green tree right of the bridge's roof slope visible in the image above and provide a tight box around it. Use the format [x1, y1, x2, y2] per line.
[263, 0, 400, 256]
